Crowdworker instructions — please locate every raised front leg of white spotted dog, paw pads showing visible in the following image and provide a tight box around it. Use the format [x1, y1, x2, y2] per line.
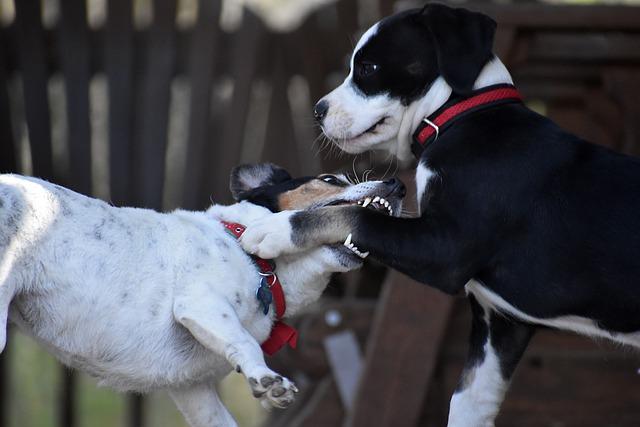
[174, 295, 298, 408]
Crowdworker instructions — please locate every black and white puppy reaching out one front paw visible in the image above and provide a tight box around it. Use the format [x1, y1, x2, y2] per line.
[242, 4, 640, 426]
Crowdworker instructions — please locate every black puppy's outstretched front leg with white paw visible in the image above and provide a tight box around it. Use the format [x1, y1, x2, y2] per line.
[240, 206, 470, 294]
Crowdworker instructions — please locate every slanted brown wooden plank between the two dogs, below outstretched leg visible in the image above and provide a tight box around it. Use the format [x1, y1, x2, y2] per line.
[347, 271, 453, 427]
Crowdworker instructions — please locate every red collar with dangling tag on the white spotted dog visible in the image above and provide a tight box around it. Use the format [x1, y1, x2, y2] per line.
[220, 221, 298, 356]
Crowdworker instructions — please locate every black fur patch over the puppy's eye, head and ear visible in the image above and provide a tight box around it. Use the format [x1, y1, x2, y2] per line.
[353, 4, 496, 105]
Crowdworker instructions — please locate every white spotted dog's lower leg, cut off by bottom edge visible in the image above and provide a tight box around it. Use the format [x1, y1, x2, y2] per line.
[169, 383, 237, 427]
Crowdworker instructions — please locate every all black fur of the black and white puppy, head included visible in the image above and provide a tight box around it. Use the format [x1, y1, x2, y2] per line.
[302, 0, 640, 414]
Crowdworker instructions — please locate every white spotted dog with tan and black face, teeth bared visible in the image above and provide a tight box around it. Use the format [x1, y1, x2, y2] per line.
[0, 164, 404, 427]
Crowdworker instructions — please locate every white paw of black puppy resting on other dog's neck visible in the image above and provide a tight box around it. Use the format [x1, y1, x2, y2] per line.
[240, 211, 296, 259]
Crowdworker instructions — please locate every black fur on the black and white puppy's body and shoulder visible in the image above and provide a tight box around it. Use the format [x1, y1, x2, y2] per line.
[316, 104, 640, 333]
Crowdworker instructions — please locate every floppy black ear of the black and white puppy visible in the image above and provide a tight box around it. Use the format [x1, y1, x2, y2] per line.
[419, 4, 496, 95]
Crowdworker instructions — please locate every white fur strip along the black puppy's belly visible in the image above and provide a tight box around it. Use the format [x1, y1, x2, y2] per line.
[465, 280, 640, 348]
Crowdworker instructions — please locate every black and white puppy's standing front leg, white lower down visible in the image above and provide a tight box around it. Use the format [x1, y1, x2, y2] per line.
[448, 295, 535, 427]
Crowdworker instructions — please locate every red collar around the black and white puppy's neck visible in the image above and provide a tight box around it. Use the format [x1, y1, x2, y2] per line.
[411, 84, 522, 158]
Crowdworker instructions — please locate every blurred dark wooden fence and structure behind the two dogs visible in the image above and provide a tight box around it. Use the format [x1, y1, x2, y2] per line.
[0, 0, 640, 427]
